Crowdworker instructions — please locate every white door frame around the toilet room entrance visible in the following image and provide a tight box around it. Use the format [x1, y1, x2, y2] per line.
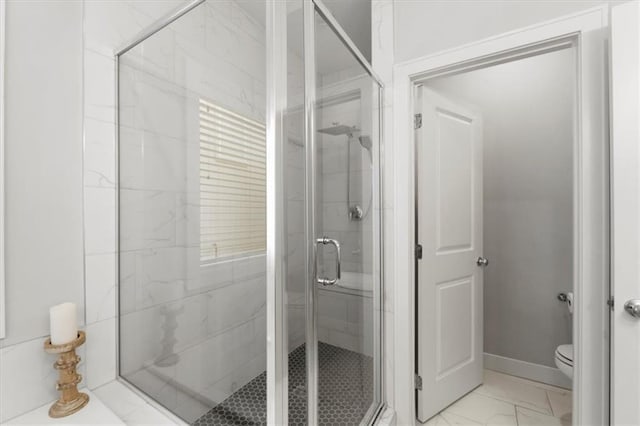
[393, 5, 610, 425]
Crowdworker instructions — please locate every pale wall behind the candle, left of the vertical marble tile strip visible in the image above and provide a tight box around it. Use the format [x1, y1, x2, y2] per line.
[0, 1, 85, 421]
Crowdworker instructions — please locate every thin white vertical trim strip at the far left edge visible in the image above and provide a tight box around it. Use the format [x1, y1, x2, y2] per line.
[0, 0, 7, 339]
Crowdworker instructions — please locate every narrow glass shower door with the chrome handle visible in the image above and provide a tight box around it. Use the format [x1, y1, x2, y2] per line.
[314, 8, 381, 425]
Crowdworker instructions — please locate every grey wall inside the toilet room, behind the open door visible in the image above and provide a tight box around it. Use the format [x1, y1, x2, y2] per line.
[430, 50, 574, 367]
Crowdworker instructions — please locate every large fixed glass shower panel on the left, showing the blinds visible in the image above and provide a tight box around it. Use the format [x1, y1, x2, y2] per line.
[118, 0, 266, 424]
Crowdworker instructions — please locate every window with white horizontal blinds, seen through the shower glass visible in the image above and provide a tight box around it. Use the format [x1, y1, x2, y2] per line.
[200, 99, 266, 263]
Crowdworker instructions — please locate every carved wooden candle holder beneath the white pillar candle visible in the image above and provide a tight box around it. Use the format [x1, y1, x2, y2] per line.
[44, 331, 89, 418]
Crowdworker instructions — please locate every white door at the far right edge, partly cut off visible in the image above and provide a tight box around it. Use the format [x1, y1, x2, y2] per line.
[611, 1, 640, 425]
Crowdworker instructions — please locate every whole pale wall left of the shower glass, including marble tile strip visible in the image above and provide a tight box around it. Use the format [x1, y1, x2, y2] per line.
[0, 0, 188, 421]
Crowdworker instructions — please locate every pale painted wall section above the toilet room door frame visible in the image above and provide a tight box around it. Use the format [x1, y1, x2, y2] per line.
[392, 0, 621, 62]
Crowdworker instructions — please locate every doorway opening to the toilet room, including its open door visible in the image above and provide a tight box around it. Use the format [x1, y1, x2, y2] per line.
[414, 38, 606, 425]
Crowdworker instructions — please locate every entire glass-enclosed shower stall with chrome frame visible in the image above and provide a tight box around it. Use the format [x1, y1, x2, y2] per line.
[116, 0, 384, 425]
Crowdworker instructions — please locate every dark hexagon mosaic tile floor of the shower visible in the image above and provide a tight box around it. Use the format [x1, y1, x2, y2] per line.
[193, 342, 373, 426]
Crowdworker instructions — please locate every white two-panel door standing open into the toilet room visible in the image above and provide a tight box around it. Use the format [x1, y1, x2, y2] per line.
[416, 86, 483, 421]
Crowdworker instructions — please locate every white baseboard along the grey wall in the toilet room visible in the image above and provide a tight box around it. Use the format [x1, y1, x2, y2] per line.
[484, 352, 571, 389]
